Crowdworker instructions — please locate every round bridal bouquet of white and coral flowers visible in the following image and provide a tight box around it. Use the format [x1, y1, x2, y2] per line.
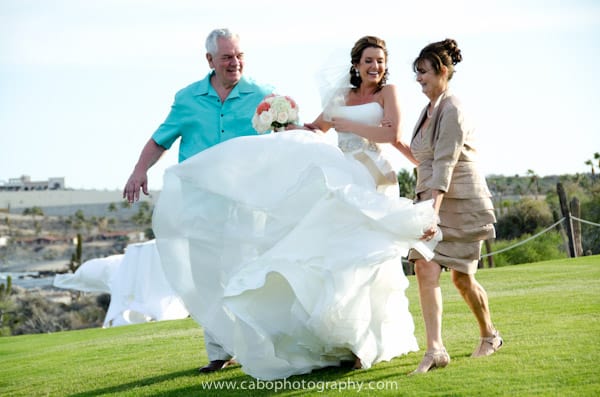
[252, 94, 298, 134]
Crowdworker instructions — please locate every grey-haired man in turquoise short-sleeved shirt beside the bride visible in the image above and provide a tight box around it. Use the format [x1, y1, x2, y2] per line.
[123, 29, 273, 372]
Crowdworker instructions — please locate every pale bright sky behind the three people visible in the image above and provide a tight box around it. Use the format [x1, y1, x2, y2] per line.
[0, 0, 600, 189]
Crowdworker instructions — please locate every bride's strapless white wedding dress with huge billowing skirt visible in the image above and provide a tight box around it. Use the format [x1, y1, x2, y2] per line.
[154, 104, 433, 380]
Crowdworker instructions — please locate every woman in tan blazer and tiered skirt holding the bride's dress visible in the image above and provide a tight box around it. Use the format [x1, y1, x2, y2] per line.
[409, 39, 503, 374]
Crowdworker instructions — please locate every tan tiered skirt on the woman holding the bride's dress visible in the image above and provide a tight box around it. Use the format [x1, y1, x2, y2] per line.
[408, 190, 496, 274]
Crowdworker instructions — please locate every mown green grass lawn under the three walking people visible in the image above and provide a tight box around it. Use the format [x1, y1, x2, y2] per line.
[0, 256, 600, 396]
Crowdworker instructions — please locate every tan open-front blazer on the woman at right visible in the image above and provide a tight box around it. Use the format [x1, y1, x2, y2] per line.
[411, 91, 491, 199]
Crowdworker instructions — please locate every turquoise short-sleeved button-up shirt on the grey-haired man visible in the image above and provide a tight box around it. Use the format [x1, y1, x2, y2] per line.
[152, 72, 273, 162]
